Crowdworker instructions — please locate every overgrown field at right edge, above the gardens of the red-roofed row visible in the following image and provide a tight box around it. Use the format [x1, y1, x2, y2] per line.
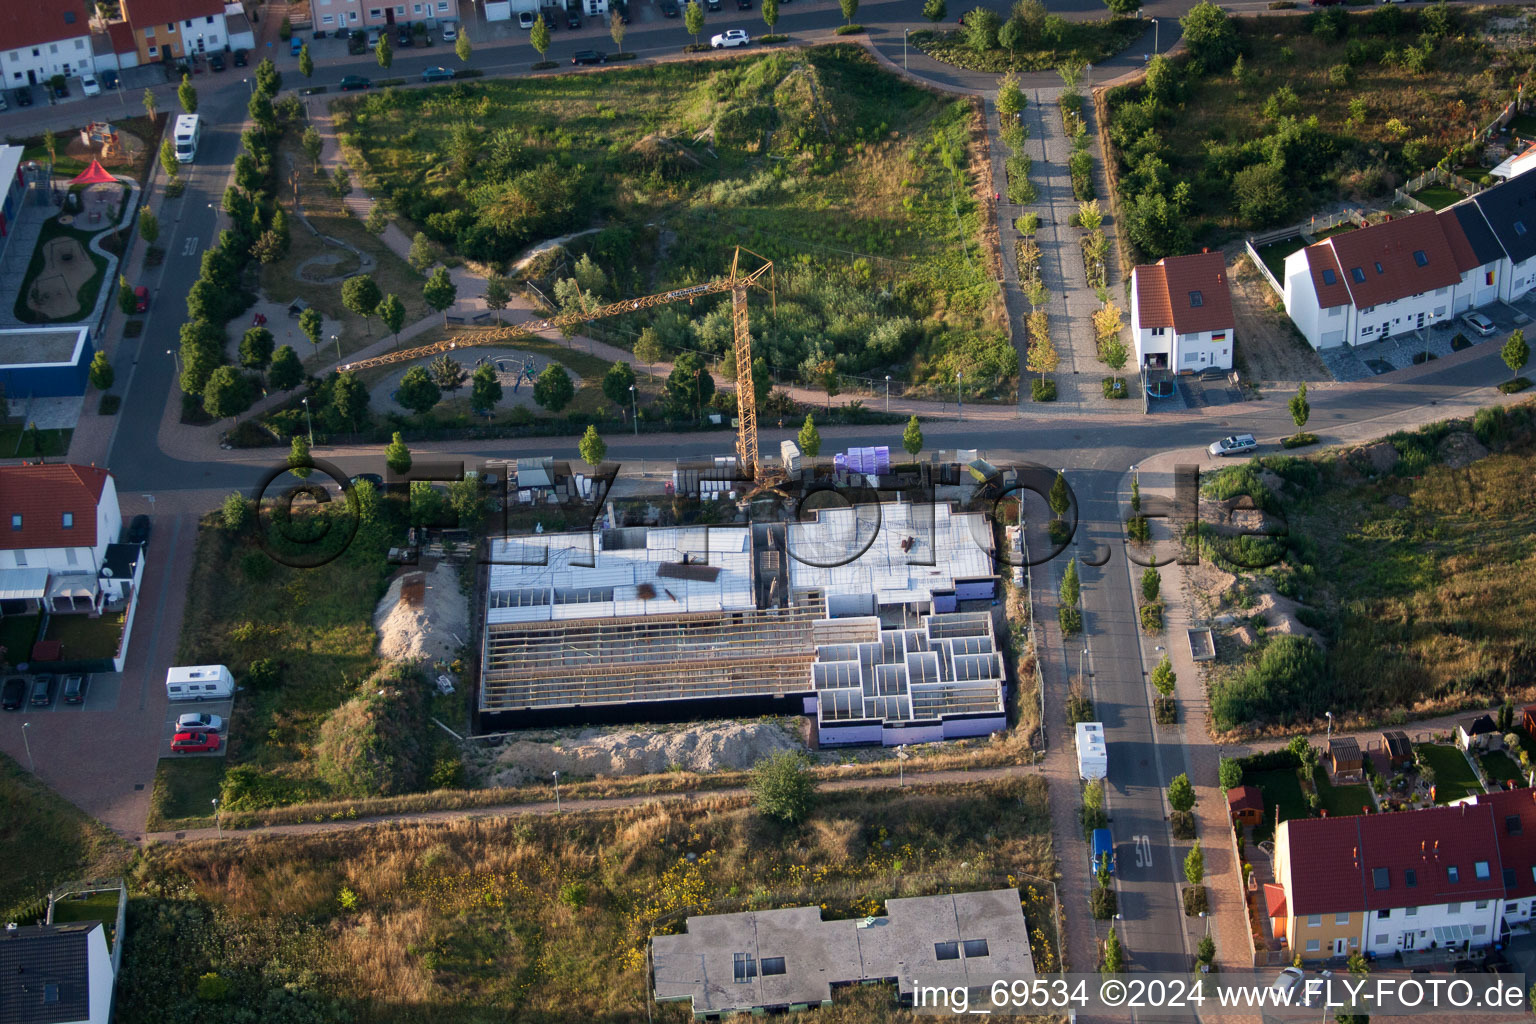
[1201, 402, 1536, 732]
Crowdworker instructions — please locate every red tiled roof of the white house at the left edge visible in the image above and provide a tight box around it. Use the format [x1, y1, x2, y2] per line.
[0, 465, 108, 551]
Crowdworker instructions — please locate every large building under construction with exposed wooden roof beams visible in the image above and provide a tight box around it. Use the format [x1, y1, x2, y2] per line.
[479, 504, 1006, 746]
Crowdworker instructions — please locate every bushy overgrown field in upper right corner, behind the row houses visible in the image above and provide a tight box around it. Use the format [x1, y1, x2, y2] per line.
[1106, 3, 1533, 259]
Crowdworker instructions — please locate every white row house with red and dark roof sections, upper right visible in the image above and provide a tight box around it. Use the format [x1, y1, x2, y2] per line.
[1281, 166, 1536, 348]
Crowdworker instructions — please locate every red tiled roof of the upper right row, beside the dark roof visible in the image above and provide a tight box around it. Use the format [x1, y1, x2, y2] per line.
[1318, 213, 1461, 309]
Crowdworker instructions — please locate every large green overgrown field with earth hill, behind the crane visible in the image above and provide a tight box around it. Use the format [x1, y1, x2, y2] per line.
[333, 46, 1017, 393]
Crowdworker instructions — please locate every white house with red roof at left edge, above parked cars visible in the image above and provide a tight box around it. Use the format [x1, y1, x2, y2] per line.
[0, 464, 119, 616]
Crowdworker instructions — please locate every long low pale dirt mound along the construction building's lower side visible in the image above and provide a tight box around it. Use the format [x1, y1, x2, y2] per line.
[473, 720, 805, 786]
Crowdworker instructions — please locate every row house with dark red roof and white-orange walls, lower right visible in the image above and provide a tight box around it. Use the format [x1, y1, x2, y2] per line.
[1270, 789, 1536, 960]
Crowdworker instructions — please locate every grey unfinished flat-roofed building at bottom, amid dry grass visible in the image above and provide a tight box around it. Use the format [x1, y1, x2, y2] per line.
[651, 889, 1035, 1019]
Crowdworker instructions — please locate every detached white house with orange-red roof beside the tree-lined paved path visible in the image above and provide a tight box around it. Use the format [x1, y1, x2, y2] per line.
[1130, 252, 1235, 373]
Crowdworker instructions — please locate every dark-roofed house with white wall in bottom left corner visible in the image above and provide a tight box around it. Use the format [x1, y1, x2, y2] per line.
[0, 921, 115, 1024]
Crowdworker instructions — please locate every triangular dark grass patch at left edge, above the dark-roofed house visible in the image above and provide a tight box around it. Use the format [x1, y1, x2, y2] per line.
[0, 754, 132, 921]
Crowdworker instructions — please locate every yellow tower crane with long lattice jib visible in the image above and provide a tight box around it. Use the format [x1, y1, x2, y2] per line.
[341, 246, 777, 479]
